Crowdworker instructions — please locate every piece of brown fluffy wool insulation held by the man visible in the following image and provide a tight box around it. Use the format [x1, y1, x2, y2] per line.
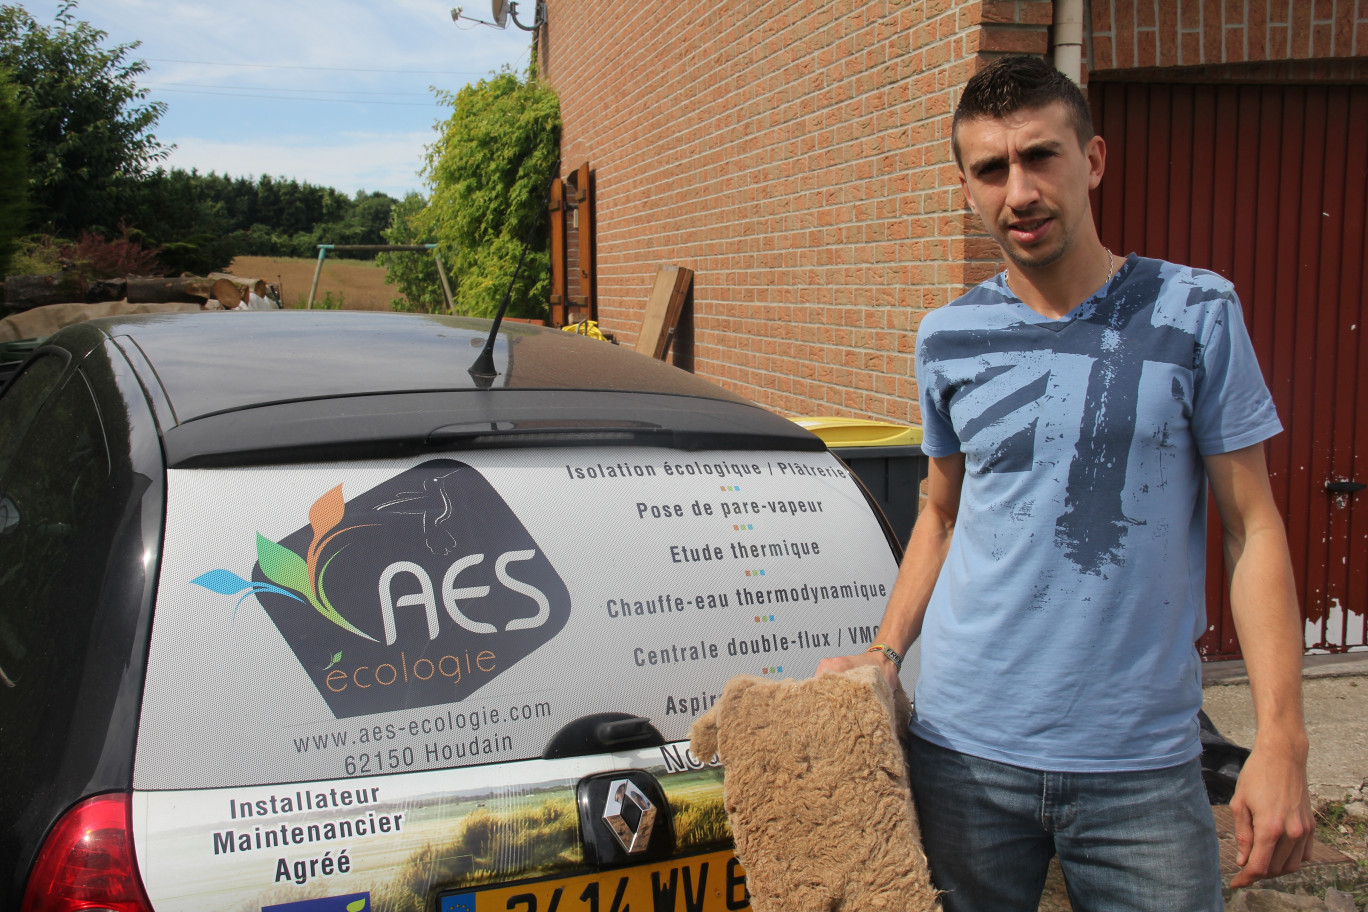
[689, 666, 940, 912]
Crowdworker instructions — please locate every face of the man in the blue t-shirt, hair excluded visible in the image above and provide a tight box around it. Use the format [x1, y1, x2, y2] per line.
[956, 103, 1105, 268]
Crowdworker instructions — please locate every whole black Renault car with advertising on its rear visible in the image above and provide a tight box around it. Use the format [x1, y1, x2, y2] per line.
[0, 312, 915, 912]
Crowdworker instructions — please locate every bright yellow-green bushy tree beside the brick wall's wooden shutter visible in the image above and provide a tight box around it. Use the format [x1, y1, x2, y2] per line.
[417, 70, 561, 317]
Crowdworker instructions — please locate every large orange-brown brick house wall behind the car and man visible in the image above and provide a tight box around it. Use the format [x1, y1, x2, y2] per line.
[543, 0, 1006, 421]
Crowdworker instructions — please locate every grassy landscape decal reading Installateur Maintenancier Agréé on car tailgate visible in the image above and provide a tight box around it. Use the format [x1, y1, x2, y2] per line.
[133, 744, 746, 912]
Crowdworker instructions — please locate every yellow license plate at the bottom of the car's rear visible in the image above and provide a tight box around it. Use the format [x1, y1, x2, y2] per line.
[438, 852, 751, 912]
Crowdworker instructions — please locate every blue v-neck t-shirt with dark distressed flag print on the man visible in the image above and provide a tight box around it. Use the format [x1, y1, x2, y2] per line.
[912, 254, 1282, 773]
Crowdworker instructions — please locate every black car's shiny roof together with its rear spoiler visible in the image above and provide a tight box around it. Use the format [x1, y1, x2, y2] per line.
[51, 310, 824, 466]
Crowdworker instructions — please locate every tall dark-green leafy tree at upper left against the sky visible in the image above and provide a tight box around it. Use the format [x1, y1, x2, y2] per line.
[0, 0, 168, 237]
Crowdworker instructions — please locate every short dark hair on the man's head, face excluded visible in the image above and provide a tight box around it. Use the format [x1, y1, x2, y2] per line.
[949, 56, 1093, 164]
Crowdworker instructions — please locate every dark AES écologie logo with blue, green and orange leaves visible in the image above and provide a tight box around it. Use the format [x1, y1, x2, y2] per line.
[193, 459, 570, 718]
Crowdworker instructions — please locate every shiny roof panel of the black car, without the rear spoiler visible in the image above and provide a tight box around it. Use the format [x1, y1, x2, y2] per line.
[72, 310, 760, 421]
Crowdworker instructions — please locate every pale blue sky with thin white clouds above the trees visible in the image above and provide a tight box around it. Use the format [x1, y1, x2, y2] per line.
[22, 0, 534, 198]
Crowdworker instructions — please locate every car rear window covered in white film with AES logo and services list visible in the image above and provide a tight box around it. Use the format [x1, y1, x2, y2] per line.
[134, 447, 897, 789]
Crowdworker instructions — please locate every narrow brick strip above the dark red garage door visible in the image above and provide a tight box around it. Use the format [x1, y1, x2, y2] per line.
[1089, 0, 1368, 77]
